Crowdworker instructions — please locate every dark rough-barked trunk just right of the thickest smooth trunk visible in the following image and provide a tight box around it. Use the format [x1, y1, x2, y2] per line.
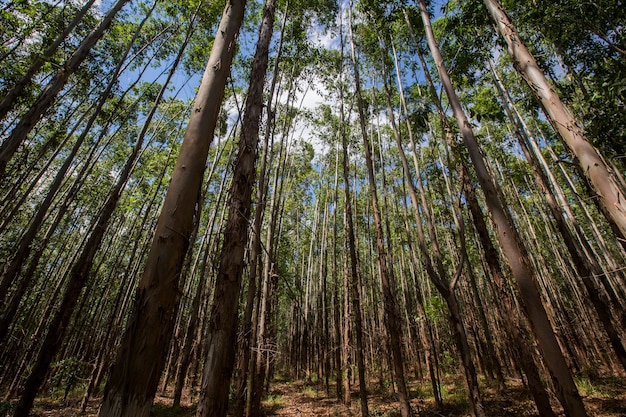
[196, 0, 276, 417]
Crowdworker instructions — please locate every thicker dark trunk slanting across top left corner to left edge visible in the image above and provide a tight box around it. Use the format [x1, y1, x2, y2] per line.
[0, 0, 128, 178]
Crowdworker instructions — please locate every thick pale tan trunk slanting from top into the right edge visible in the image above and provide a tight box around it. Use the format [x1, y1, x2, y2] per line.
[484, 0, 626, 247]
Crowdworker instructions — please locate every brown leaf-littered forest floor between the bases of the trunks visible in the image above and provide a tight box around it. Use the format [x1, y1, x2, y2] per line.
[13, 375, 626, 417]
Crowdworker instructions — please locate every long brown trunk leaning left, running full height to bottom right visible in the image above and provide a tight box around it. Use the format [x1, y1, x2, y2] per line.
[419, 0, 587, 417]
